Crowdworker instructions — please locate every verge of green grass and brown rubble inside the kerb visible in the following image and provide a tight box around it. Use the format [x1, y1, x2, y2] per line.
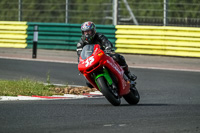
[0, 79, 96, 96]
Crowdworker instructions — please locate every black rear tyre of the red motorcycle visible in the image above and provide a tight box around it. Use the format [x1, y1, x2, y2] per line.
[123, 86, 140, 105]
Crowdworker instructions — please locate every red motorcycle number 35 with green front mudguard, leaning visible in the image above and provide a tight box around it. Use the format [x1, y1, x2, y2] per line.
[78, 44, 140, 106]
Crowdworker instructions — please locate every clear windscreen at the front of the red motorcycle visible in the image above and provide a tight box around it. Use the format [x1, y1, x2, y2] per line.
[81, 44, 95, 59]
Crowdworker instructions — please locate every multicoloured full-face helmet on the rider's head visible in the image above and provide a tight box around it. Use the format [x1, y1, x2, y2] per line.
[81, 21, 96, 43]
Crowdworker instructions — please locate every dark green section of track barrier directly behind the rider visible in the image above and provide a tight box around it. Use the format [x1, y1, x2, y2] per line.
[27, 22, 116, 50]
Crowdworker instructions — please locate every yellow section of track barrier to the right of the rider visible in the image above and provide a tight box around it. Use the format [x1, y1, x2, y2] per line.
[115, 25, 200, 57]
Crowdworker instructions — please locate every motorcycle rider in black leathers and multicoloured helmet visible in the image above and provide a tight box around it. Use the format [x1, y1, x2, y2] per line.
[77, 21, 137, 81]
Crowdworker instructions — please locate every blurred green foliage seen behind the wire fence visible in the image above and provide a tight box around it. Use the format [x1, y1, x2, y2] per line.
[0, 0, 200, 24]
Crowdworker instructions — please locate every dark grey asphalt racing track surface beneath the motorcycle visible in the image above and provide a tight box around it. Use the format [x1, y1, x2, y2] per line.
[0, 59, 200, 133]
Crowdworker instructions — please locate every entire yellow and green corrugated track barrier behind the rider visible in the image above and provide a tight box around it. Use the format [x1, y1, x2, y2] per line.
[0, 21, 200, 57]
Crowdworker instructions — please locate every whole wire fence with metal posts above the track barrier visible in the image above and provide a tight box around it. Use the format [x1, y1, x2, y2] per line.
[0, 0, 200, 27]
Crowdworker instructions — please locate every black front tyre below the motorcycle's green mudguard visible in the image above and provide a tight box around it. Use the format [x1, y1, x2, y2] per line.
[97, 77, 121, 106]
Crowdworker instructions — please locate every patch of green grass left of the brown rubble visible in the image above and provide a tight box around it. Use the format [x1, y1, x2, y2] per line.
[0, 79, 63, 96]
